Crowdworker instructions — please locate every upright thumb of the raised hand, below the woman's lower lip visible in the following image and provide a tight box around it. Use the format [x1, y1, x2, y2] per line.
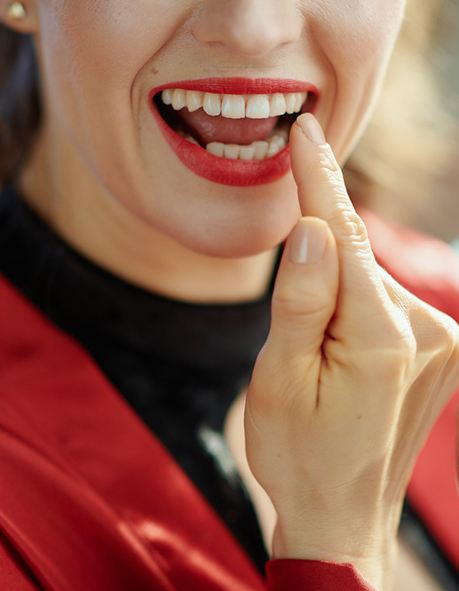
[266, 216, 339, 357]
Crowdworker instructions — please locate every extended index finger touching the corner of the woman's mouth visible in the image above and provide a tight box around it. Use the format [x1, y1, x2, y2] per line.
[290, 113, 393, 337]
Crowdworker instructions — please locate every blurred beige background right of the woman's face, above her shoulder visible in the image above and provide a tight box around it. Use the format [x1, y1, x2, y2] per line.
[346, 0, 459, 252]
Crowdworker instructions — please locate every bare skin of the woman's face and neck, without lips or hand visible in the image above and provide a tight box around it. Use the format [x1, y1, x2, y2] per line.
[4, 0, 404, 301]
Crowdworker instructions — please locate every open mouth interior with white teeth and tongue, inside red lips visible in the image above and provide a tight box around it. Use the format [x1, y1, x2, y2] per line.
[153, 88, 318, 160]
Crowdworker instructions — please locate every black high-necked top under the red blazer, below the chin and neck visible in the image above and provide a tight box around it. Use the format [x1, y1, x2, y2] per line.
[0, 186, 459, 591]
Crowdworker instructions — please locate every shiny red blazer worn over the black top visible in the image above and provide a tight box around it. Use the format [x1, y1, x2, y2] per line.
[0, 211, 459, 591]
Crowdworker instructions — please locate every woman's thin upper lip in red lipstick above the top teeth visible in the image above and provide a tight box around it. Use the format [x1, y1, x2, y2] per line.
[149, 77, 320, 98]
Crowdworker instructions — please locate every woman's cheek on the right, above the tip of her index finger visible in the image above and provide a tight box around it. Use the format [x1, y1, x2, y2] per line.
[310, 0, 405, 164]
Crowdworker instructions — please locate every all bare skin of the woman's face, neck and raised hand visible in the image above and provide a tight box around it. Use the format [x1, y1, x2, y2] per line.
[5, 0, 459, 589]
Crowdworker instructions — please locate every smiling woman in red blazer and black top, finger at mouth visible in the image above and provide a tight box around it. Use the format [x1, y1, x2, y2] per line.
[0, 0, 459, 591]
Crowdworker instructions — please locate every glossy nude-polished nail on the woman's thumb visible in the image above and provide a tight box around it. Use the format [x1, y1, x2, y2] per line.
[289, 221, 328, 264]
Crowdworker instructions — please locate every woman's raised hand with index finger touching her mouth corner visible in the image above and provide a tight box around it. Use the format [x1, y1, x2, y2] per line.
[244, 114, 459, 588]
